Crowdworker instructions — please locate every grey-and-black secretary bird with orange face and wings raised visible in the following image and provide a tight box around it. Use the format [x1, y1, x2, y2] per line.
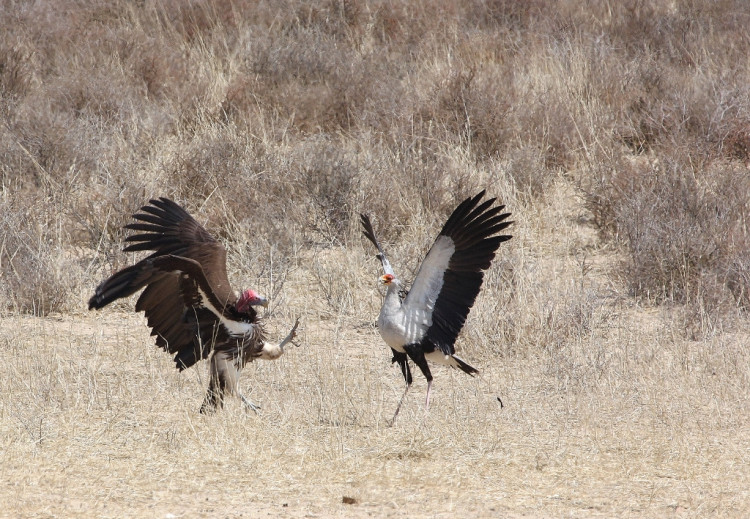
[360, 191, 512, 423]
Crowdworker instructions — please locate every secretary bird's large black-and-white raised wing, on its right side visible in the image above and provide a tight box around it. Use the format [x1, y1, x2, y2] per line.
[403, 191, 512, 355]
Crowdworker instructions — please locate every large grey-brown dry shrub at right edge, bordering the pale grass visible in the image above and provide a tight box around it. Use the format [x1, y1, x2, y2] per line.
[587, 153, 750, 318]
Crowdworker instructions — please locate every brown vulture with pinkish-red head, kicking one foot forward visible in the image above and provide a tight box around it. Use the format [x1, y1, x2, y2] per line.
[89, 197, 297, 413]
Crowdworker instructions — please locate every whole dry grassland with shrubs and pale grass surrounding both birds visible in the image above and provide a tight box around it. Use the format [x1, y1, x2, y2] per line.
[0, 0, 750, 518]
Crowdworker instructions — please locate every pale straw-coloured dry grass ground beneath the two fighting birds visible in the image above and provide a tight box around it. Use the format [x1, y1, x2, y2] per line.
[0, 189, 750, 517]
